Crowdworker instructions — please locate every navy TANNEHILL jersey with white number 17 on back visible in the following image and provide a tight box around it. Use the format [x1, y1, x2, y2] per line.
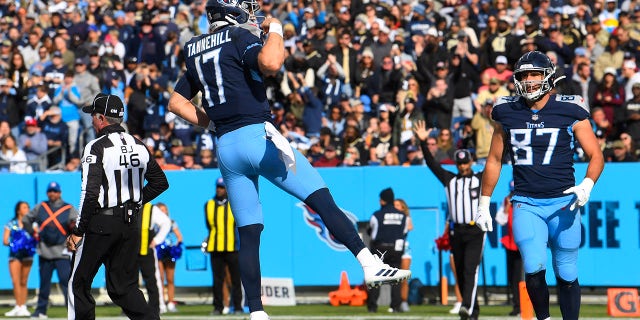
[175, 25, 271, 137]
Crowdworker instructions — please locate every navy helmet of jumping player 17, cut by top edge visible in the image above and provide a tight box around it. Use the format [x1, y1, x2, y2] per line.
[206, 0, 260, 32]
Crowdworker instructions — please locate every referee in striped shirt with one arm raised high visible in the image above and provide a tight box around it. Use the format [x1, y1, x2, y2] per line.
[414, 121, 485, 319]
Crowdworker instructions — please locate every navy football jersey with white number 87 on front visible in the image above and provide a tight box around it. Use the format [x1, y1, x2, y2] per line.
[492, 95, 589, 198]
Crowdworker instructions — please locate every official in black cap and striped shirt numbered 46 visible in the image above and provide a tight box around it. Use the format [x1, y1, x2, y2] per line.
[67, 94, 169, 320]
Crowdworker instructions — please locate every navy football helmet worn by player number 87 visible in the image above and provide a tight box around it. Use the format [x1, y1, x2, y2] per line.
[513, 51, 556, 101]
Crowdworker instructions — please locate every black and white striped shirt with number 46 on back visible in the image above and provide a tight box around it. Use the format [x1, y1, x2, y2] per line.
[74, 125, 169, 234]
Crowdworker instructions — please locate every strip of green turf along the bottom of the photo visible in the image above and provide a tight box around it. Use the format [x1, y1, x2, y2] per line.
[17, 304, 612, 320]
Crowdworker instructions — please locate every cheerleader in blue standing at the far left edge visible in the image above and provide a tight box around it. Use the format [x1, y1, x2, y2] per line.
[2, 201, 36, 317]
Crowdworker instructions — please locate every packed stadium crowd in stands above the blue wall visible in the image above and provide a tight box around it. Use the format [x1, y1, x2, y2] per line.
[0, 0, 640, 172]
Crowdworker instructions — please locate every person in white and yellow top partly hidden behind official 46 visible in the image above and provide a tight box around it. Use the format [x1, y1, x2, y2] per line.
[138, 203, 171, 314]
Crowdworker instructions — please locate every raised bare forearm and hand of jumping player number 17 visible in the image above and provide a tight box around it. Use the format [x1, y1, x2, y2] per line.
[258, 17, 285, 75]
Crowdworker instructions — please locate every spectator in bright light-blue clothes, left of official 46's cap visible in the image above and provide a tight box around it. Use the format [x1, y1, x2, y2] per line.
[53, 70, 81, 153]
